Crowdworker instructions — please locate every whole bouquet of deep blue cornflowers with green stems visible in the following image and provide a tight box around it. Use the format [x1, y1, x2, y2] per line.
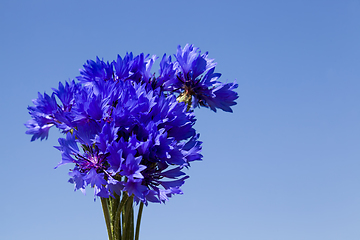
[25, 44, 238, 240]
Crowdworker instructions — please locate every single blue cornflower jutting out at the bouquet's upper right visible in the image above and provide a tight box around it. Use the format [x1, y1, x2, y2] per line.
[171, 44, 238, 112]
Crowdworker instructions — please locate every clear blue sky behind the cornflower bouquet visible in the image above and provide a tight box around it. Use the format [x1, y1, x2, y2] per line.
[0, 0, 360, 240]
